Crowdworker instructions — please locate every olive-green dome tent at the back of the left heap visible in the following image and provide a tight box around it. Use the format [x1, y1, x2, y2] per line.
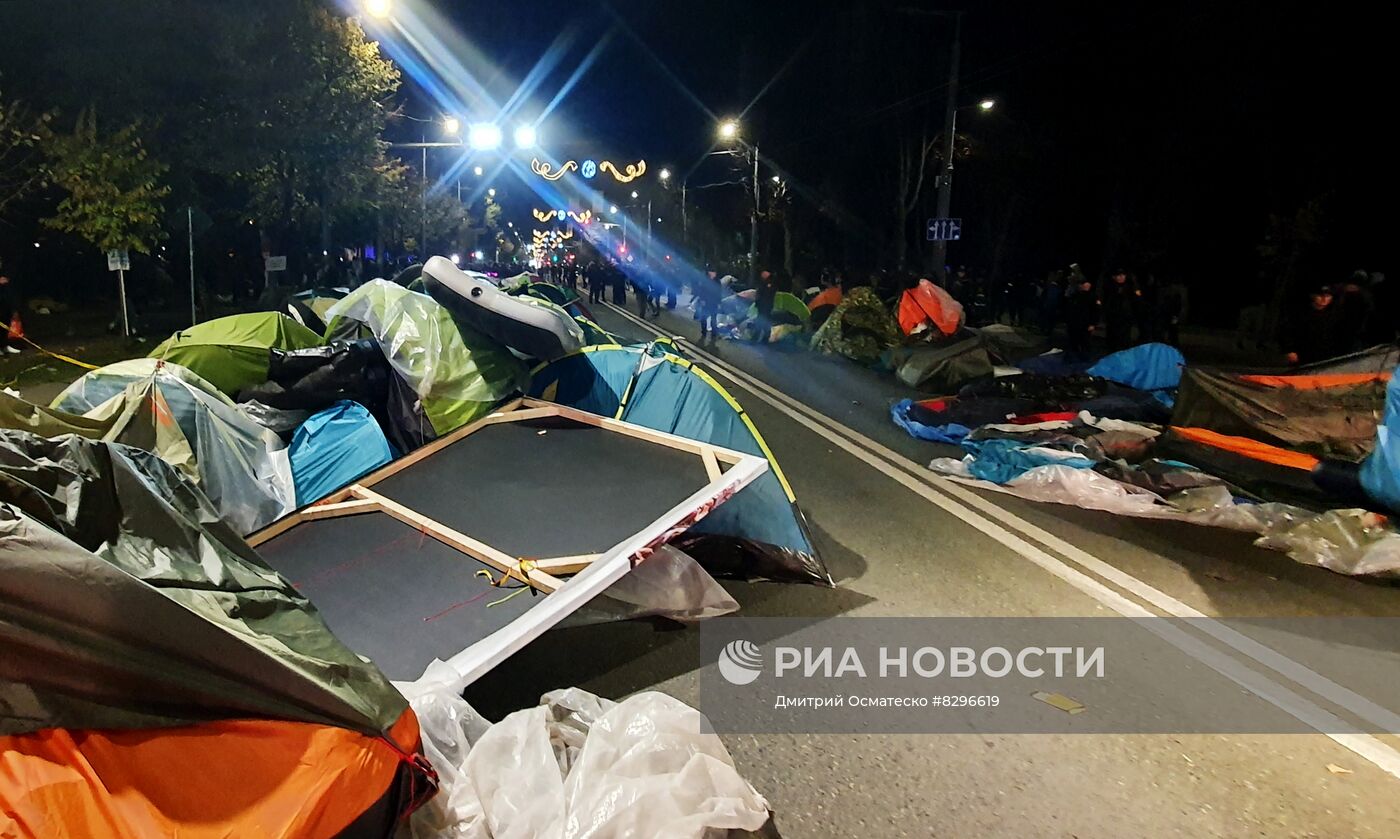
[150, 312, 322, 396]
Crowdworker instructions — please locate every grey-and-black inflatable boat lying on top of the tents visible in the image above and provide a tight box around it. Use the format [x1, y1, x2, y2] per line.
[423, 256, 584, 361]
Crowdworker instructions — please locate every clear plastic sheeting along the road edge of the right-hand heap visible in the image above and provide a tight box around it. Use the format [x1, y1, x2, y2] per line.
[928, 458, 1400, 577]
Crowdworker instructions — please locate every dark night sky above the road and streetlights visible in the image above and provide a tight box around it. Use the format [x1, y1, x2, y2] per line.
[389, 0, 1394, 317]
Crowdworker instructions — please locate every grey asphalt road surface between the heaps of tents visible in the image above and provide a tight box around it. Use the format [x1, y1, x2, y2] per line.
[468, 292, 1400, 838]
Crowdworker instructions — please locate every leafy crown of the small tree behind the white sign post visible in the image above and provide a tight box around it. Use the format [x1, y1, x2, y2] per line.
[45, 109, 169, 254]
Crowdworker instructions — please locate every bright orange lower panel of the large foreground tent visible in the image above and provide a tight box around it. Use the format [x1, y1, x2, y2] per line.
[0, 712, 419, 839]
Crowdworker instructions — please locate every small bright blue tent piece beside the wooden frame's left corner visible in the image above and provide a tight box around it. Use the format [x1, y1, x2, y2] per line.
[290, 402, 396, 507]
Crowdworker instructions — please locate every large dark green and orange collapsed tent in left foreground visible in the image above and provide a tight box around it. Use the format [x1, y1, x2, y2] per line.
[0, 431, 435, 839]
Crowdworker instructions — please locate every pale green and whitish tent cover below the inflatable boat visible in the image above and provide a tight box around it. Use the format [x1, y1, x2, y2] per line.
[328, 280, 526, 436]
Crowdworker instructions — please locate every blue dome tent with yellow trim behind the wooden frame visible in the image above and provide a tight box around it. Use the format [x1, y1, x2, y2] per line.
[529, 343, 832, 584]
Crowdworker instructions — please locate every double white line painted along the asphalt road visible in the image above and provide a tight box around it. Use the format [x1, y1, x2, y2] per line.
[608, 304, 1400, 779]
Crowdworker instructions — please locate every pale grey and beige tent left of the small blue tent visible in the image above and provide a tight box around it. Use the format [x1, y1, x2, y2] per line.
[0, 360, 295, 534]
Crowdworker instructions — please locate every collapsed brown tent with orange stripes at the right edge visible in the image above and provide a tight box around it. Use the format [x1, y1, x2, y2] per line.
[1172, 367, 1390, 462]
